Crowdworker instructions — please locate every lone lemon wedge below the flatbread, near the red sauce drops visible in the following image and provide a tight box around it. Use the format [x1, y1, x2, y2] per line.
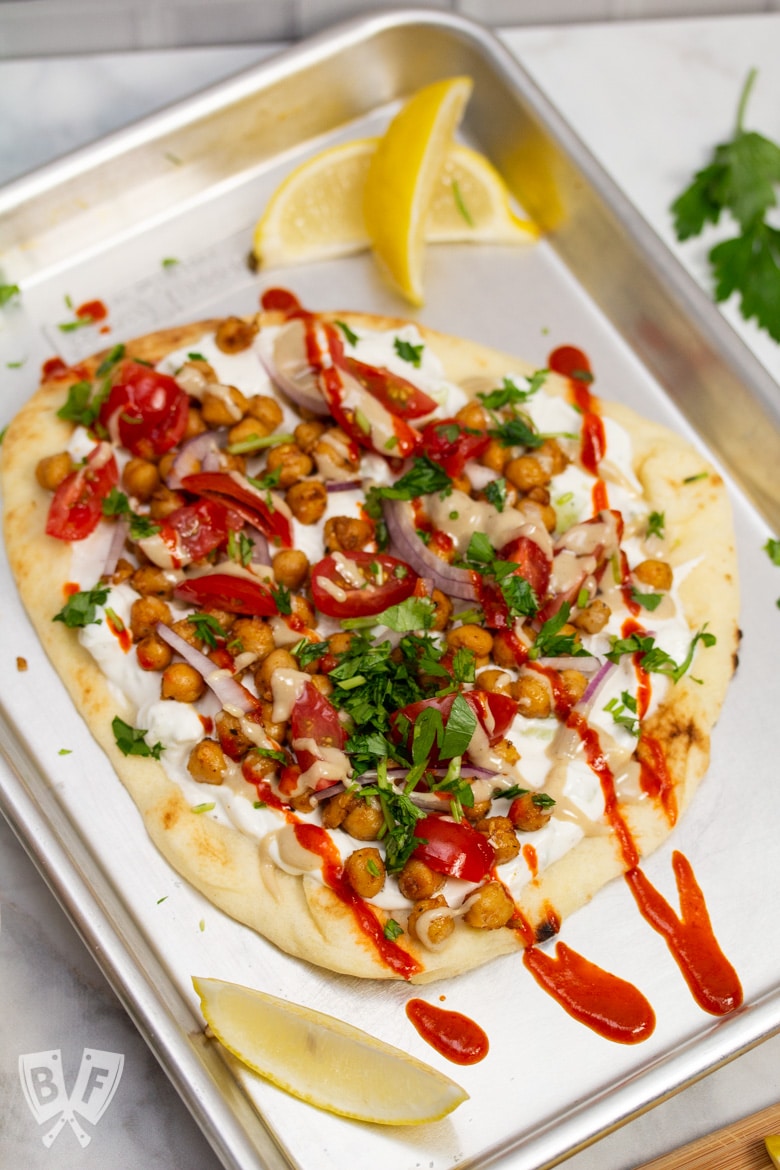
[192, 977, 468, 1126]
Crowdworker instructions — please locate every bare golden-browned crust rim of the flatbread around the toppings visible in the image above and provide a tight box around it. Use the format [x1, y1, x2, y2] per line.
[1, 312, 739, 982]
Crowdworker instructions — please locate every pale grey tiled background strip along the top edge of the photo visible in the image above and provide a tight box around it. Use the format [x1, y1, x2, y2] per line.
[0, 0, 780, 57]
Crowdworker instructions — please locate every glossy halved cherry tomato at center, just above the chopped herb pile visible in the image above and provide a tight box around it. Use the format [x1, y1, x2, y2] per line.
[311, 551, 417, 618]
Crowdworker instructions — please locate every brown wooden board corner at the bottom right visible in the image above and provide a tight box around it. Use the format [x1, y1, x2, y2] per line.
[636, 1104, 780, 1170]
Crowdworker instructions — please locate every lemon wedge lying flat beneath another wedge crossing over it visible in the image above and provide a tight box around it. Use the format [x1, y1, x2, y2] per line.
[254, 138, 540, 268]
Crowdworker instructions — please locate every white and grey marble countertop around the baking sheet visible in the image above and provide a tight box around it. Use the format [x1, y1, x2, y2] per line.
[0, 14, 780, 1170]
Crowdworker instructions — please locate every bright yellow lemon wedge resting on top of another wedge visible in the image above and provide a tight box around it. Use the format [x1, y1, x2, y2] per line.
[363, 77, 472, 305]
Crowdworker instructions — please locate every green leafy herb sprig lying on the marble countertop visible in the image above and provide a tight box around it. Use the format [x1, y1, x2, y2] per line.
[671, 69, 780, 342]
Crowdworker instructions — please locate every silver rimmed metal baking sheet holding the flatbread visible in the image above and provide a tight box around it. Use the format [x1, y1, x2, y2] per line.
[0, 11, 780, 1170]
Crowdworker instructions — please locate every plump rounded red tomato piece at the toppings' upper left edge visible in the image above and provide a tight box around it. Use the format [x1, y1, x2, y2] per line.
[98, 362, 189, 459]
